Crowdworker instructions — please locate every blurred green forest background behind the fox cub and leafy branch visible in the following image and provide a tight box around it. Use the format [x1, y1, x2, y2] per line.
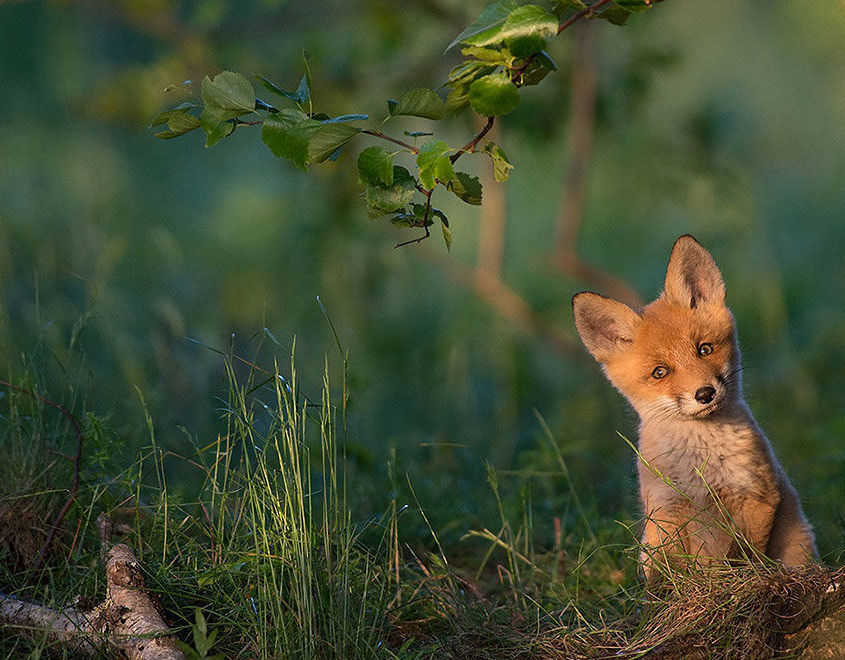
[0, 0, 845, 561]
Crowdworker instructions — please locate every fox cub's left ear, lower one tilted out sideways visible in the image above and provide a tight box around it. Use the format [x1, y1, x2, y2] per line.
[572, 291, 642, 362]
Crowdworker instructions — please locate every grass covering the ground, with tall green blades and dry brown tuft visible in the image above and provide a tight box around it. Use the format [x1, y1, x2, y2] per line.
[0, 355, 829, 659]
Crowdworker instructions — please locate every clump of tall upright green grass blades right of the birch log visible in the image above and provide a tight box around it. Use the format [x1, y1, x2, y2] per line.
[190, 348, 395, 658]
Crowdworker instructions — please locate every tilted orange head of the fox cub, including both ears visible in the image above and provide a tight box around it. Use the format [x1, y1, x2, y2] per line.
[572, 235, 741, 420]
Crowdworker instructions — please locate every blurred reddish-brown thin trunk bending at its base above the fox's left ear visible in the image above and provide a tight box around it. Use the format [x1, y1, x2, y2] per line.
[553, 24, 642, 308]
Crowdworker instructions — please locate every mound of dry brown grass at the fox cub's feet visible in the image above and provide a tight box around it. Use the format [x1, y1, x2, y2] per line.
[548, 564, 845, 660]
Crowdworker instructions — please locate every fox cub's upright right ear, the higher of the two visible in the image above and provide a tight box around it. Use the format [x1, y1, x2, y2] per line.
[663, 234, 725, 309]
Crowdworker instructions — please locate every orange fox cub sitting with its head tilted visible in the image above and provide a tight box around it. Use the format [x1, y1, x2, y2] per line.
[572, 235, 816, 577]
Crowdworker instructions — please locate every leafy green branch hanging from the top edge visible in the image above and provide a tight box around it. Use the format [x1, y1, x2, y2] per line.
[152, 0, 659, 248]
